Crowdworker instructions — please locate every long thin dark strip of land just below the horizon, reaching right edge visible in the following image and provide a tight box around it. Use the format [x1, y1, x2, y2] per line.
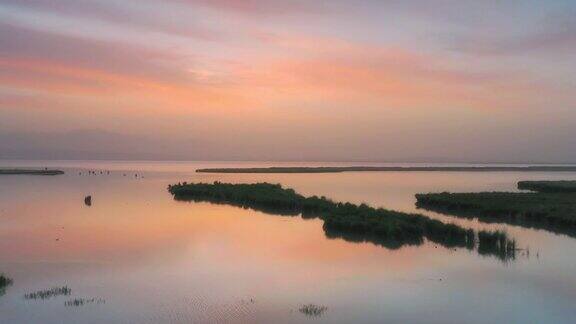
[196, 166, 576, 173]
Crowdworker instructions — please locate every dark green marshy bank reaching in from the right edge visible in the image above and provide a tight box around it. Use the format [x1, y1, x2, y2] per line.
[416, 182, 576, 237]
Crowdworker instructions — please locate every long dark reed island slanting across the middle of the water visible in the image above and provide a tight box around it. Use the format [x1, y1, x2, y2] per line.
[168, 182, 515, 260]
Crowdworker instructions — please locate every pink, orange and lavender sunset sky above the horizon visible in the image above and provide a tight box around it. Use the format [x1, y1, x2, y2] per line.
[0, 0, 576, 163]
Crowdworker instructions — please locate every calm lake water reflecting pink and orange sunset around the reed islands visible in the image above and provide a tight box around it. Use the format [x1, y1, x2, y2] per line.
[0, 161, 576, 323]
